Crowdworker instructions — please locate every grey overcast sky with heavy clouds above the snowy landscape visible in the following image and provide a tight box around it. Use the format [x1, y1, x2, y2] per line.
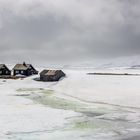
[0, 0, 140, 62]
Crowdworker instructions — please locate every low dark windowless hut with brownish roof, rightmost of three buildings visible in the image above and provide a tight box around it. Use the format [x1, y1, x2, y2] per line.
[40, 70, 65, 81]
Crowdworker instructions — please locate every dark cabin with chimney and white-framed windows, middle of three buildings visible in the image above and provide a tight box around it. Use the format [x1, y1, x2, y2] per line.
[13, 62, 38, 76]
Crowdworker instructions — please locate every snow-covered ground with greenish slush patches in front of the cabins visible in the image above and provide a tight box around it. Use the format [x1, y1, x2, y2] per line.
[0, 69, 140, 140]
